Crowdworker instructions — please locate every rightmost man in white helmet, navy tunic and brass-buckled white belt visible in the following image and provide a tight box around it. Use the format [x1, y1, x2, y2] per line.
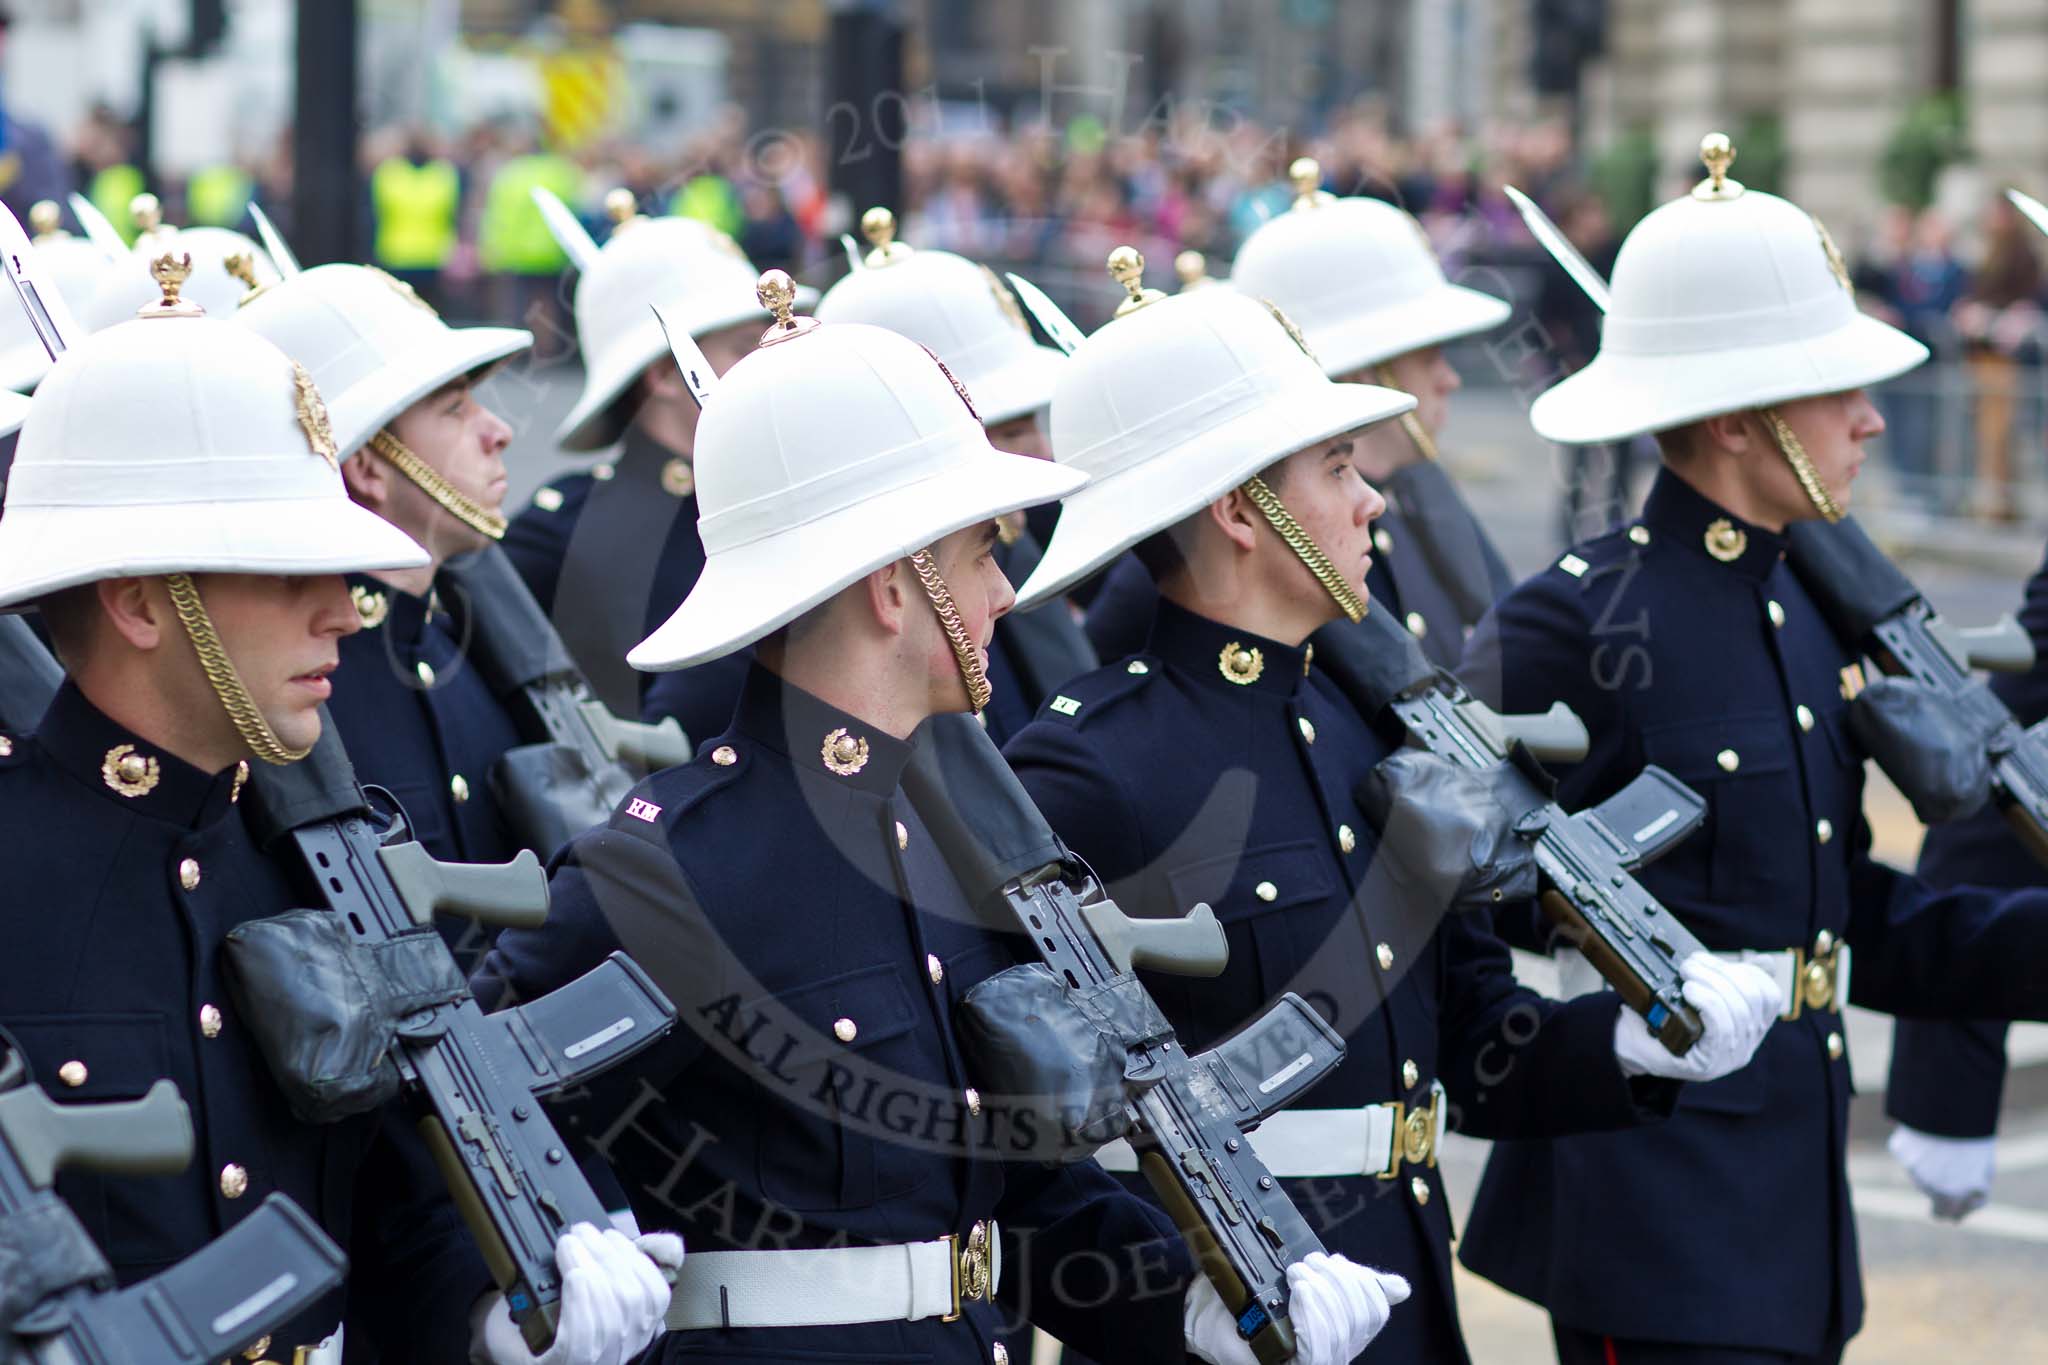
[1460, 137, 2048, 1365]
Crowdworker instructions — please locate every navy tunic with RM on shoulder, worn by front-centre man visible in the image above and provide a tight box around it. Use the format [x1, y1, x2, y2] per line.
[477, 667, 1190, 1365]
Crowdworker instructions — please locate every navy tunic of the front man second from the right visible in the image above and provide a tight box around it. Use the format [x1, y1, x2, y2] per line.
[1006, 600, 1675, 1361]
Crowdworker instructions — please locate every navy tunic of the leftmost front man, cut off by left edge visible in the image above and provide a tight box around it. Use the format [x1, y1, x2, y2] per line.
[0, 684, 489, 1365]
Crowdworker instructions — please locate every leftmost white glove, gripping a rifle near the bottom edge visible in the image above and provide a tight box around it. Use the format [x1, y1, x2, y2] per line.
[469, 1224, 682, 1365]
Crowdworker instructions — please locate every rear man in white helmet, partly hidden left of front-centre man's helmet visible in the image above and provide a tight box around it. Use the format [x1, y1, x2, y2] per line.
[504, 190, 815, 739]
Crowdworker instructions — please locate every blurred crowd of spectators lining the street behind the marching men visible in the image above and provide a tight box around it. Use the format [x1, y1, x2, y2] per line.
[6, 86, 2048, 518]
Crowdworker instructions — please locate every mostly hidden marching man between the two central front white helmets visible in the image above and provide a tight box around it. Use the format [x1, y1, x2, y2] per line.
[806, 209, 1096, 745]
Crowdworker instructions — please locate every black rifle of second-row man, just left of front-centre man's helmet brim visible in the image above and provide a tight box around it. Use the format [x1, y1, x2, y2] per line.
[438, 544, 690, 851]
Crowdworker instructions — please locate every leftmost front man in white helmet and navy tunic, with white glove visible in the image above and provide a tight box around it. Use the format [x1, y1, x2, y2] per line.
[0, 256, 666, 1365]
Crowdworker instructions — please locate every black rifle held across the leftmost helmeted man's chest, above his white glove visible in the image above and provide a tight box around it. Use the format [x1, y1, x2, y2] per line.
[244, 716, 676, 1353]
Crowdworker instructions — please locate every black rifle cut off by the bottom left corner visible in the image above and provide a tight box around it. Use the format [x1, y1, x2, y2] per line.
[0, 1038, 348, 1365]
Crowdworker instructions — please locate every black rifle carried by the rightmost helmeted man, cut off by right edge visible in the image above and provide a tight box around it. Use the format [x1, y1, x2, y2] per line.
[1786, 518, 2048, 862]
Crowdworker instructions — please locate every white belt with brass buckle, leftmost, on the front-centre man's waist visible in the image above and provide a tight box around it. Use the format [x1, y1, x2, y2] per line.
[668, 1222, 1004, 1332]
